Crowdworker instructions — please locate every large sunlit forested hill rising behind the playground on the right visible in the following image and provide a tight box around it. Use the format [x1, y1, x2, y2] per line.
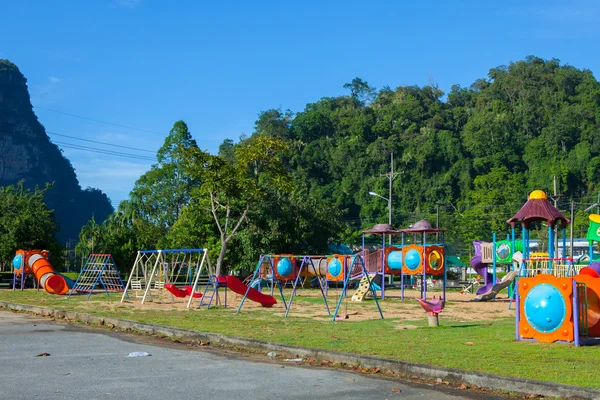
[246, 57, 600, 247]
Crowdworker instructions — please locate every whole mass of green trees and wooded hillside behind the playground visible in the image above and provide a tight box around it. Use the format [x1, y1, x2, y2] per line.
[82, 57, 600, 268]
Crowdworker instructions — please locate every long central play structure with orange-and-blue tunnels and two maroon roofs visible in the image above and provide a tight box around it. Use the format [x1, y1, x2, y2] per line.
[238, 221, 446, 321]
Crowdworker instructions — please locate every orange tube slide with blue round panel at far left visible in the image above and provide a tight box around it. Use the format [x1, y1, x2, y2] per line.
[13, 250, 69, 294]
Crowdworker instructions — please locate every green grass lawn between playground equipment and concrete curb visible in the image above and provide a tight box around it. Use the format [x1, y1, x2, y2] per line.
[0, 290, 600, 388]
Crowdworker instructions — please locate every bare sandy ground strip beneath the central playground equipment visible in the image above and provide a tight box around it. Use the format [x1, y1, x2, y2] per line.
[99, 288, 515, 329]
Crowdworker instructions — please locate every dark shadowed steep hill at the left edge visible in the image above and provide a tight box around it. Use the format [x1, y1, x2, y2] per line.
[0, 59, 113, 243]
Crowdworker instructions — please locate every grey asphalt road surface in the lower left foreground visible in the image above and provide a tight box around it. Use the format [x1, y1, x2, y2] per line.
[0, 311, 504, 400]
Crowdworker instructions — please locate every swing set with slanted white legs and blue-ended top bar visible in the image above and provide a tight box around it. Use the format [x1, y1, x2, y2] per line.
[121, 249, 214, 308]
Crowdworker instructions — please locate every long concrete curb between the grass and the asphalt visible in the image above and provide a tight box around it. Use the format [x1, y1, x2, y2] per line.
[0, 301, 600, 400]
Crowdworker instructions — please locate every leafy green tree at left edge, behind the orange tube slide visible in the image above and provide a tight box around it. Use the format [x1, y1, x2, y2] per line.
[0, 182, 62, 270]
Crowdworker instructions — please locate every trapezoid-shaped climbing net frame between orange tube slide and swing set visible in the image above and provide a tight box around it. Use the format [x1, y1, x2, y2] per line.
[68, 254, 125, 299]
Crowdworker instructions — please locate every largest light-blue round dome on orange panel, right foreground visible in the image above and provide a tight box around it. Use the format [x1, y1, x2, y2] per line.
[524, 283, 567, 333]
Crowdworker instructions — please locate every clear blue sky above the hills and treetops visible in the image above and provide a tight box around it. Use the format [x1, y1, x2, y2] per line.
[0, 0, 600, 204]
